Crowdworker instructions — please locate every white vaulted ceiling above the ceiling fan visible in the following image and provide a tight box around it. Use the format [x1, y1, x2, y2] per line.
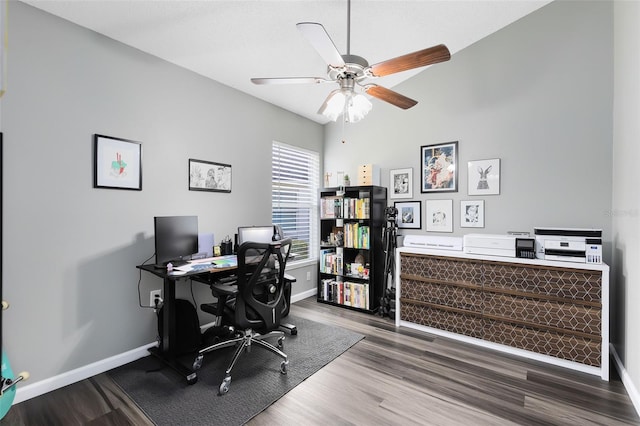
[20, 0, 550, 123]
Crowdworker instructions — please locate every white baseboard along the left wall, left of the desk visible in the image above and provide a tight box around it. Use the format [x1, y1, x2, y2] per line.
[13, 343, 157, 404]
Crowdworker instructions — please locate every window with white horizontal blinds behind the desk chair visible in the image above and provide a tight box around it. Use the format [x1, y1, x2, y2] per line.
[271, 142, 320, 262]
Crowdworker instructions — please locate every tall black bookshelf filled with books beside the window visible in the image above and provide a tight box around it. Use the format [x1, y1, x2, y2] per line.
[317, 186, 387, 313]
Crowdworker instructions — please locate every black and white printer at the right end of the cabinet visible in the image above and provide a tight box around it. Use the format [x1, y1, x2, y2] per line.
[533, 228, 602, 263]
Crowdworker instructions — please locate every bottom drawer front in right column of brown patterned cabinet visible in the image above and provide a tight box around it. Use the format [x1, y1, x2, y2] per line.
[484, 319, 601, 367]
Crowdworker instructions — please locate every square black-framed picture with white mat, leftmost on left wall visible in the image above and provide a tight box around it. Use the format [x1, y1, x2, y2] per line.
[93, 134, 142, 191]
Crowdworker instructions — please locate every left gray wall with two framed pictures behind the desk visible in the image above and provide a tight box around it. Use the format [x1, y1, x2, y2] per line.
[2, 2, 323, 383]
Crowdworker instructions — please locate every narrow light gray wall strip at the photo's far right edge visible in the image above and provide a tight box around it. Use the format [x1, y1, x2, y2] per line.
[611, 1, 640, 407]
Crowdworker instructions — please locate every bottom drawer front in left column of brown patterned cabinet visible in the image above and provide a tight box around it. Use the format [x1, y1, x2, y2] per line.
[400, 301, 484, 339]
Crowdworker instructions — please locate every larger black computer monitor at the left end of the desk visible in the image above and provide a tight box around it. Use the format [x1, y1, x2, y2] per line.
[154, 216, 198, 265]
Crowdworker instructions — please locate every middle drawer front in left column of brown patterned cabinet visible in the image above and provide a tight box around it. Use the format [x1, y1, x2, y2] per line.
[400, 279, 483, 313]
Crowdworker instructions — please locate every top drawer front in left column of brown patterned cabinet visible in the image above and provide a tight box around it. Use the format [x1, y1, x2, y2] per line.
[400, 253, 482, 285]
